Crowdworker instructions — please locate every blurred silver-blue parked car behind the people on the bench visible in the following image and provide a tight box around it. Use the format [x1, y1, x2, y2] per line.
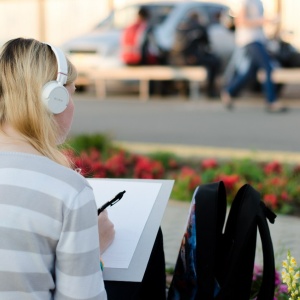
[61, 1, 234, 86]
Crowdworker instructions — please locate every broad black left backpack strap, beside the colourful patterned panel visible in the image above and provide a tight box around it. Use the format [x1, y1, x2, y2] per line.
[195, 181, 226, 300]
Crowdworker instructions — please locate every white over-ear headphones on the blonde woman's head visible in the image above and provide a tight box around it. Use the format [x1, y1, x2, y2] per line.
[42, 43, 69, 114]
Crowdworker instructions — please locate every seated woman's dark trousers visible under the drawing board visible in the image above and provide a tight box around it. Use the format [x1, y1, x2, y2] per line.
[104, 228, 166, 300]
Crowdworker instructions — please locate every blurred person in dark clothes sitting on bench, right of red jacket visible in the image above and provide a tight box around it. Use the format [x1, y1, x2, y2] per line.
[169, 12, 221, 98]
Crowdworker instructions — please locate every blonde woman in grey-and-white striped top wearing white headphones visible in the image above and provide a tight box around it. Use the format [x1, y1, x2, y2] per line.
[0, 38, 114, 300]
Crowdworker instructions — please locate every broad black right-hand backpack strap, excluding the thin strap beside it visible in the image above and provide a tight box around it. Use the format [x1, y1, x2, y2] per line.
[217, 184, 260, 300]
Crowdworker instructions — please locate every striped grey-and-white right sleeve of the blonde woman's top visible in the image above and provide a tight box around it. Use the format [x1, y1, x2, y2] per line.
[54, 187, 107, 300]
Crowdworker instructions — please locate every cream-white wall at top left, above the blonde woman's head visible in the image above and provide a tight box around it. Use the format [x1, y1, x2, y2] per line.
[0, 0, 109, 45]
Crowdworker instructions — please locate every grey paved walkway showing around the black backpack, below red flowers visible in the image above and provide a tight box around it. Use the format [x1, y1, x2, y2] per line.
[161, 200, 300, 267]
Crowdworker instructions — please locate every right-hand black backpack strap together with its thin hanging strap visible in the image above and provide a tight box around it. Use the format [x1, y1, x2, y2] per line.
[217, 184, 275, 300]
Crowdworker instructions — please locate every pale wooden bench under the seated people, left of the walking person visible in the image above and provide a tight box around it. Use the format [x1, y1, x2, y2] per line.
[94, 66, 207, 101]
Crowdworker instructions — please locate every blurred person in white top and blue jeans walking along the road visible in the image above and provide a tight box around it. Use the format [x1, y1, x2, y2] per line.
[221, 0, 287, 112]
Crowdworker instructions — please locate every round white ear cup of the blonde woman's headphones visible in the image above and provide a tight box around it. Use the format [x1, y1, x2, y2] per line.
[42, 81, 69, 114]
